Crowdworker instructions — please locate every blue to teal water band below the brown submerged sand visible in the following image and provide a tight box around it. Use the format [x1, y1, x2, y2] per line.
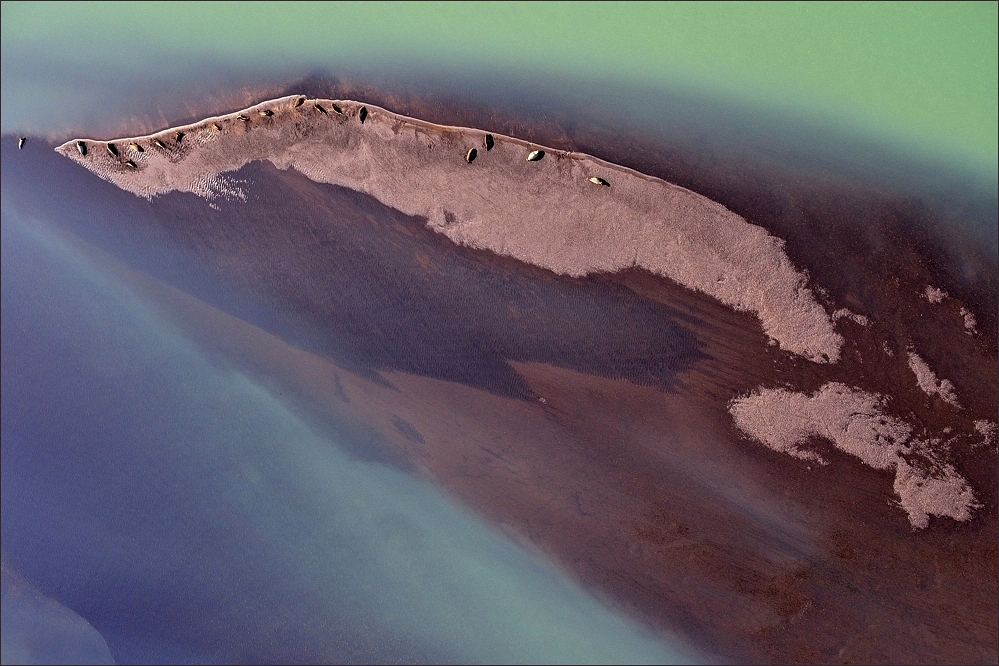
[2, 210, 704, 663]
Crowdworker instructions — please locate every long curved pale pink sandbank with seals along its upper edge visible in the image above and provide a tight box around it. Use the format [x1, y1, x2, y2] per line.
[56, 96, 843, 363]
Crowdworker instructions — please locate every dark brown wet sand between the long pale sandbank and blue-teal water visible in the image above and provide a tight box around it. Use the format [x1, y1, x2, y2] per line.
[3, 84, 997, 663]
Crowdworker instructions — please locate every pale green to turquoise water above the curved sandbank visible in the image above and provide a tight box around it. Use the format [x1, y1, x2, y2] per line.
[2, 2, 999, 176]
